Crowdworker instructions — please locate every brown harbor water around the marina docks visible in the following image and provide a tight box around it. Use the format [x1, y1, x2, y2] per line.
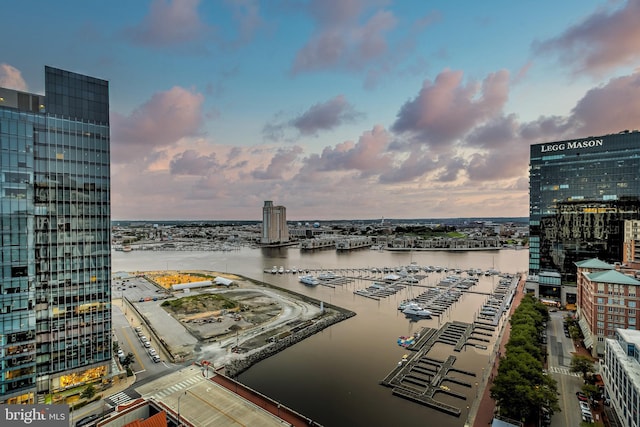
[112, 247, 528, 427]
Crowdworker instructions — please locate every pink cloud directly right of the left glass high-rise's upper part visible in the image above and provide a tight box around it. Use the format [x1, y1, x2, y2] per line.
[111, 86, 204, 163]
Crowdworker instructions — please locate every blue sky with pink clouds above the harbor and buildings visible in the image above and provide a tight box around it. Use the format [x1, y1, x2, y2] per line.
[0, 0, 640, 221]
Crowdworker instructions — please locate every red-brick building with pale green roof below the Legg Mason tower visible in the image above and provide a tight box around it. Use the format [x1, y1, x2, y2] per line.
[576, 259, 640, 356]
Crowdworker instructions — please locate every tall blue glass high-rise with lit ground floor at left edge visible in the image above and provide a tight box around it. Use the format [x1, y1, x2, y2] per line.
[0, 67, 112, 403]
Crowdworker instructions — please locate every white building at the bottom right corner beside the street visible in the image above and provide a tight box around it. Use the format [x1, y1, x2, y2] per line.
[601, 329, 640, 427]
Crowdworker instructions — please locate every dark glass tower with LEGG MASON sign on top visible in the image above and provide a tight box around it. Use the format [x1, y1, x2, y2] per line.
[527, 131, 640, 306]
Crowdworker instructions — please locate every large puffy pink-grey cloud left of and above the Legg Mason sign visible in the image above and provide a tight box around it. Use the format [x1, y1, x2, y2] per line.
[391, 70, 509, 150]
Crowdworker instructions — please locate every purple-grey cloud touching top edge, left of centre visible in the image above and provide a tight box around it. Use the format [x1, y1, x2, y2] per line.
[125, 0, 212, 47]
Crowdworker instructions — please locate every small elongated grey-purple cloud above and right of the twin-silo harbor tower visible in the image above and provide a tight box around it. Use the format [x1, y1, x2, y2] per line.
[263, 95, 363, 140]
